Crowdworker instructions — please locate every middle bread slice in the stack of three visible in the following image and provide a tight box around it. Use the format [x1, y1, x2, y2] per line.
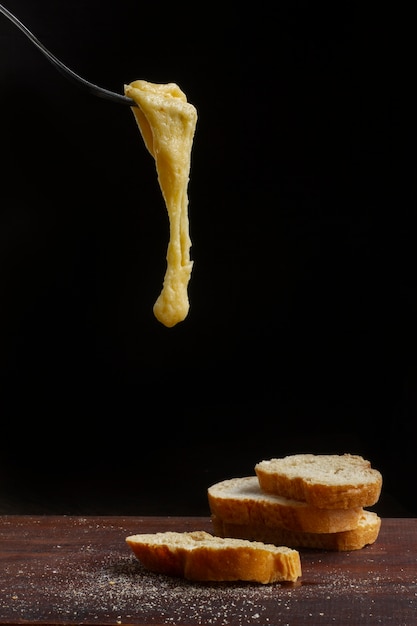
[207, 476, 363, 533]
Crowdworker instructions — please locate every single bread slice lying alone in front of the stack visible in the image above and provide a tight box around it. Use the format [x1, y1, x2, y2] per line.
[126, 531, 301, 584]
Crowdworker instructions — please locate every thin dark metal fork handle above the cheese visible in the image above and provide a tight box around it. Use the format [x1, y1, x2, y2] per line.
[0, 4, 137, 106]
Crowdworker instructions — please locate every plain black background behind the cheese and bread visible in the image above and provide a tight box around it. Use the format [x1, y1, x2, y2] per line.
[0, 0, 417, 515]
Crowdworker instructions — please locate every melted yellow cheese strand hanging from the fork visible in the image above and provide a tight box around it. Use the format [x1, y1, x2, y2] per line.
[125, 80, 197, 327]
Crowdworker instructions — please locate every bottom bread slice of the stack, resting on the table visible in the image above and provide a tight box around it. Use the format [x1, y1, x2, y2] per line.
[212, 511, 381, 552]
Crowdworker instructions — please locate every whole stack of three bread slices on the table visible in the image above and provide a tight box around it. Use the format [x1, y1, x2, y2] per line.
[208, 454, 382, 551]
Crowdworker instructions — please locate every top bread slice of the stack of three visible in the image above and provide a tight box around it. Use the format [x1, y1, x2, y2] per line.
[255, 454, 382, 509]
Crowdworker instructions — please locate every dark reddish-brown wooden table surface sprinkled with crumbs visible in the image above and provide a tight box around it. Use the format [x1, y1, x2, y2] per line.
[0, 516, 417, 626]
